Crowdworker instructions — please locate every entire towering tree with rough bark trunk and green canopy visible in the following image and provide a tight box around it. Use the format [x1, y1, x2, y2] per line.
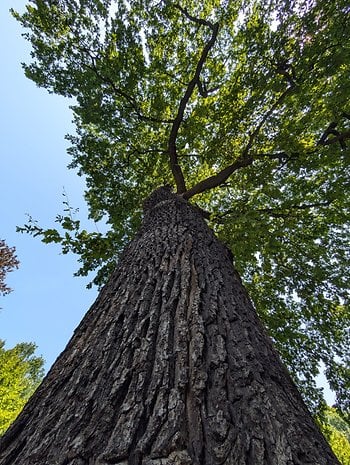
[0, 0, 350, 465]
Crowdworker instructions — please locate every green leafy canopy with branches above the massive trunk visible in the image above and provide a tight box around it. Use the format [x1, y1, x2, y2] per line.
[14, 0, 350, 411]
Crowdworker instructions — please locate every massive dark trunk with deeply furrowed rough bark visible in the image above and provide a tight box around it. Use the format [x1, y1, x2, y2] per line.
[0, 188, 339, 465]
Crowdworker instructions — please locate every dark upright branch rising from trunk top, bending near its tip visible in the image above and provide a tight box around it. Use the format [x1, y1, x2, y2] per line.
[168, 5, 219, 194]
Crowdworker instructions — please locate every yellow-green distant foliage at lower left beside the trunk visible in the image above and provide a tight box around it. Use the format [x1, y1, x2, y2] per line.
[0, 340, 44, 435]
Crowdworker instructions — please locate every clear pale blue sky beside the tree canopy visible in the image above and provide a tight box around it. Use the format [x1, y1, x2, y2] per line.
[0, 0, 334, 404]
